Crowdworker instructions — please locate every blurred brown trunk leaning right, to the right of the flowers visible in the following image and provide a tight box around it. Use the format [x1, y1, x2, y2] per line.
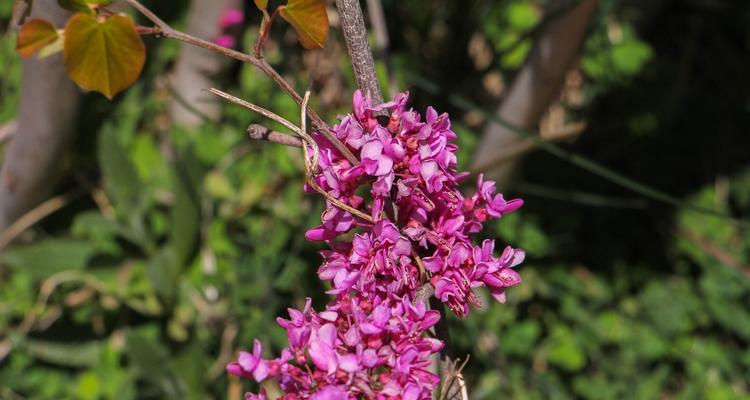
[472, 0, 598, 187]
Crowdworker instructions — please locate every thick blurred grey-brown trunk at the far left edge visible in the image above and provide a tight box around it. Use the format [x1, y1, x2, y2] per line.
[0, 1, 80, 231]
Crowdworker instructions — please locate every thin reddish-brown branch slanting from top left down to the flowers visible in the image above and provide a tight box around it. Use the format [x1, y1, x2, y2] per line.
[125, 0, 359, 165]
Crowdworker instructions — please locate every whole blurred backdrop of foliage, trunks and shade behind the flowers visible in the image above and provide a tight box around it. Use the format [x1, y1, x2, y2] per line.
[0, 0, 750, 399]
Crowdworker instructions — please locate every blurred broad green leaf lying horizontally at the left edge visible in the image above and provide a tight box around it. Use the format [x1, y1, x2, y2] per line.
[0, 239, 96, 278]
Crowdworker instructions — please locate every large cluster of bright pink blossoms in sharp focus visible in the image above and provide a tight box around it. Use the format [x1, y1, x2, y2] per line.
[232, 91, 524, 400]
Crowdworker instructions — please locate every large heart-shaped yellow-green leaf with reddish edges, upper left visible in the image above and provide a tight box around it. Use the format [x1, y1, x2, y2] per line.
[64, 13, 146, 100]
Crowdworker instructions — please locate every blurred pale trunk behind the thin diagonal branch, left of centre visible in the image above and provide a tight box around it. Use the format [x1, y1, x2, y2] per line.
[170, 0, 242, 128]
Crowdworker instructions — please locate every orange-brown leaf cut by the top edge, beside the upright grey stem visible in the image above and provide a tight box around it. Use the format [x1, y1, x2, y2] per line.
[280, 0, 328, 49]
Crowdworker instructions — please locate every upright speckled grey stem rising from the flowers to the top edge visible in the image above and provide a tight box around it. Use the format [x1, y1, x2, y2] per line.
[336, 0, 383, 104]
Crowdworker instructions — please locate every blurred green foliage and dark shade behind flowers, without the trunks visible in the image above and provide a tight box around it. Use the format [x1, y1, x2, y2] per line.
[0, 0, 750, 399]
